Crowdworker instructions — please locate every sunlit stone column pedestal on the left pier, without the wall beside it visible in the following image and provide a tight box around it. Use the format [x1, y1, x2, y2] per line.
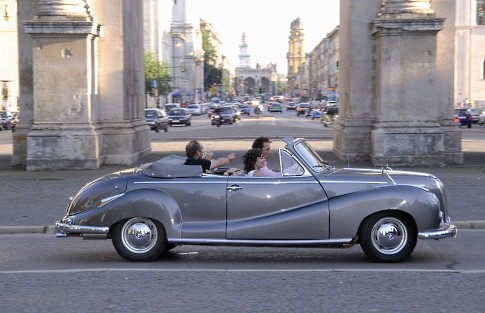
[24, 0, 101, 170]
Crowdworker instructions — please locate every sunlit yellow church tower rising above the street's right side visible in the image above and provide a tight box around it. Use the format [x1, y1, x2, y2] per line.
[286, 17, 305, 94]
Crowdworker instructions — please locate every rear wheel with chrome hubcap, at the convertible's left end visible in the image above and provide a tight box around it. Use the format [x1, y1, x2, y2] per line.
[112, 217, 167, 261]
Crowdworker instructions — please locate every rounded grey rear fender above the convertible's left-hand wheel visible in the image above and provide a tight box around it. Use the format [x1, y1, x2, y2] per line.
[75, 189, 182, 238]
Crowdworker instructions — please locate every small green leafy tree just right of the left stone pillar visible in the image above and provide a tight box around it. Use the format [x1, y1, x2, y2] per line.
[145, 52, 172, 96]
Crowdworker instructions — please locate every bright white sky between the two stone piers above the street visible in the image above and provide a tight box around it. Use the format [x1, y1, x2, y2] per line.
[186, 0, 340, 74]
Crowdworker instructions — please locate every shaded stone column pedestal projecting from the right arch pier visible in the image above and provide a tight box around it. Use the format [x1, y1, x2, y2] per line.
[370, 0, 451, 166]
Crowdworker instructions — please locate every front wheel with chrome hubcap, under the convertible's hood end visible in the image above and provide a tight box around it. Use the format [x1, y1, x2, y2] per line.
[359, 212, 417, 262]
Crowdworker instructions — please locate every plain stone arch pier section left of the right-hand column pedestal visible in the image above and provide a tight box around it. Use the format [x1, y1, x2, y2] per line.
[333, 0, 381, 162]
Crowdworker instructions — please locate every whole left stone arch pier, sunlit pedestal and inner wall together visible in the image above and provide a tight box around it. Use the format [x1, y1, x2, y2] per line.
[19, 0, 151, 170]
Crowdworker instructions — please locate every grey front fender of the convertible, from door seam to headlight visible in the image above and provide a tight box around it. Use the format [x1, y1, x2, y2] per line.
[329, 186, 441, 238]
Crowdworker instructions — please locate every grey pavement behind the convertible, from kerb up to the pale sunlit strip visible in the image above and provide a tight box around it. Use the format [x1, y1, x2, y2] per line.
[0, 138, 485, 234]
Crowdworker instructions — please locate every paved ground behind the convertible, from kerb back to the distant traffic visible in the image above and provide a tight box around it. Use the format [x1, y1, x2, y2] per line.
[0, 111, 485, 233]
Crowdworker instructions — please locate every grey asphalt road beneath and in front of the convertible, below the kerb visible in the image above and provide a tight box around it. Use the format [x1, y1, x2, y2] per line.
[0, 230, 485, 313]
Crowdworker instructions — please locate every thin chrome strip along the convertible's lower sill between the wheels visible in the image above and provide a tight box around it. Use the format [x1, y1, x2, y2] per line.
[168, 238, 353, 247]
